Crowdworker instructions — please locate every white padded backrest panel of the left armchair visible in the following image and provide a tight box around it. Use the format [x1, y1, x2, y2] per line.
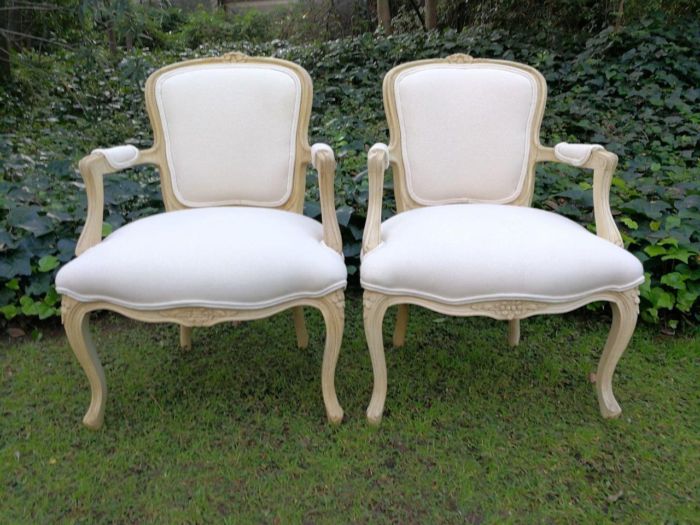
[155, 63, 301, 207]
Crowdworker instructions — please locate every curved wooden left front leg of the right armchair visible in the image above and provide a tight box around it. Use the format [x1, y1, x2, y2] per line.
[363, 291, 387, 425]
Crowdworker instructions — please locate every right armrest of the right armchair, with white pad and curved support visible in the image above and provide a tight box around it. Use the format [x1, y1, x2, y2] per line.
[537, 142, 623, 246]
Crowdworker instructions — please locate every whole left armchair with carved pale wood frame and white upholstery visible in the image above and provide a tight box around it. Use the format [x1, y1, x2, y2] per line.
[56, 53, 346, 429]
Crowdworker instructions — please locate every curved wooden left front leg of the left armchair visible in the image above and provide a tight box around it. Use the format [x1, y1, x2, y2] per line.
[61, 297, 107, 430]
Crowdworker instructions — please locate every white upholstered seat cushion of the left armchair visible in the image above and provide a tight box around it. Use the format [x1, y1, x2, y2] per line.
[56, 208, 347, 310]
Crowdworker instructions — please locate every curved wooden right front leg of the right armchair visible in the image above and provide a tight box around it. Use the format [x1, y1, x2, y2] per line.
[595, 289, 639, 419]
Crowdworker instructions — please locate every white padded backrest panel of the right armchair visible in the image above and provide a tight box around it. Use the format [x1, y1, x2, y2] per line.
[395, 64, 540, 205]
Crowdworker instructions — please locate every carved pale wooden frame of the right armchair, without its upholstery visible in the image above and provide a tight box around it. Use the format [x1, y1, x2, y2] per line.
[362, 54, 639, 424]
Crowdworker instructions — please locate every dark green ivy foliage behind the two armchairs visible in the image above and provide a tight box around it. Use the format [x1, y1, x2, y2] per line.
[0, 16, 700, 328]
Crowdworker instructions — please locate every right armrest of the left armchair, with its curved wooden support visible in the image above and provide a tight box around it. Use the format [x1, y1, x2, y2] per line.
[311, 143, 343, 254]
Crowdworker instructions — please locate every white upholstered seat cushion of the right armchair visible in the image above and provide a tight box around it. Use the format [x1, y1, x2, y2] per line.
[361, 204, 644, 304]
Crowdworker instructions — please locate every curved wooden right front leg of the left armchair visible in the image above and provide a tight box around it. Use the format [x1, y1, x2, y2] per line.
[320, 290, 345, 424]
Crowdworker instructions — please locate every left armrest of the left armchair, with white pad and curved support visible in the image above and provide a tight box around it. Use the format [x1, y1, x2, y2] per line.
[75, 146, 156, 255]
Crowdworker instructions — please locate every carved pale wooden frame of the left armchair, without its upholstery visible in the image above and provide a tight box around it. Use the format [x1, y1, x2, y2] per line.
[61, 52, 345, 429]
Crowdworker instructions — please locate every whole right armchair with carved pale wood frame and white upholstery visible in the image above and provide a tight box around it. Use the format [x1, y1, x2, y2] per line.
[361, 54, 644, 424]
